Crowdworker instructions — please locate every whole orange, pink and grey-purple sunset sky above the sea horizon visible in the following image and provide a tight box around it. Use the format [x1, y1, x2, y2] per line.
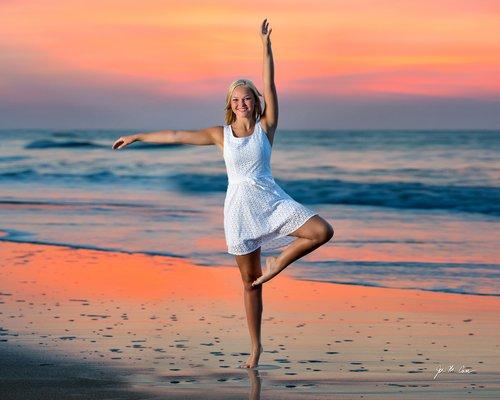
[0, 0, 500, 130]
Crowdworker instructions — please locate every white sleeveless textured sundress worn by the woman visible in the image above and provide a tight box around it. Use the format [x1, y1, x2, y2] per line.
[223, 121, 318, 255]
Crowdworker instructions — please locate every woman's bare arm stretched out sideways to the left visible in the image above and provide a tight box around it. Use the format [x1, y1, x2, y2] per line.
[113, 125, 222, 150]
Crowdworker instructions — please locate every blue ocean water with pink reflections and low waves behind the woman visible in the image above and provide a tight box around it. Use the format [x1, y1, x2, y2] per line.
[0, 130, 500, 296]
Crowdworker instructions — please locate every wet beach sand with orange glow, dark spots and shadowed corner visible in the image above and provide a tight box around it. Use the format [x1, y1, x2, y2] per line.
[0, 241, 500, 399]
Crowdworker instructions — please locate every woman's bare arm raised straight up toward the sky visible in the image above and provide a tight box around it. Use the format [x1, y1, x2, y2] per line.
[260, 18, 278, 143]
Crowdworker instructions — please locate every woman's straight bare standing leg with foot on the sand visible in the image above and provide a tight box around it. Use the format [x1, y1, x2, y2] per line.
[235, 247, 263, 368]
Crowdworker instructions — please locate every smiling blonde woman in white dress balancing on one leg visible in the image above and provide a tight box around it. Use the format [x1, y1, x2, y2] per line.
[113, 19, 334, 368]
